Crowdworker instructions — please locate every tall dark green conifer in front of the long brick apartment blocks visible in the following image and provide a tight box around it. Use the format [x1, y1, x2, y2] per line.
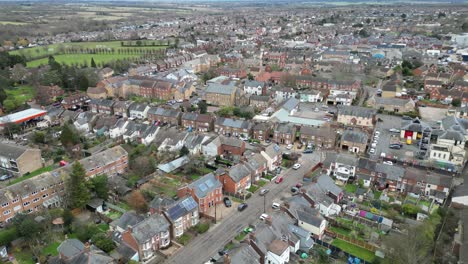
[67, 161, 91, 209]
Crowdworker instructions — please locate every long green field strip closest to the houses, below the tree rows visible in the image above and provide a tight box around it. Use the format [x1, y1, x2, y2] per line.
[27, 54, 140, 68]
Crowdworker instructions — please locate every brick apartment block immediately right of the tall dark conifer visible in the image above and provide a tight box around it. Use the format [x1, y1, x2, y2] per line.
[80, 146, 128, 178]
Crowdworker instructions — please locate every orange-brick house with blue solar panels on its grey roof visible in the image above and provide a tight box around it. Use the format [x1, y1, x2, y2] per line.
[177, 173, 223, 213]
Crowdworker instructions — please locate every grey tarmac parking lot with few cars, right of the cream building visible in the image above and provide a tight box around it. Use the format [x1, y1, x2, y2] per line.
[370, 115, 418, 160]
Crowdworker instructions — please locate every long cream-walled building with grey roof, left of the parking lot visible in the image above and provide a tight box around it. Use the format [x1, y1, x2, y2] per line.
[337, 106, 376, 127]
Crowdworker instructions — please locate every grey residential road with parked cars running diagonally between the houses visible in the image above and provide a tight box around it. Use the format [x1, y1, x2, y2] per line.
[165, 152, 321, 264]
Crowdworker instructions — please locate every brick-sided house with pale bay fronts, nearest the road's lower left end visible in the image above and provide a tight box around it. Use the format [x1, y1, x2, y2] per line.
[122, 214, 171, 261]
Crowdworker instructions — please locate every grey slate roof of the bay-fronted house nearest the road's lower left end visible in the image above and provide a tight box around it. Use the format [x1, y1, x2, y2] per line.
[132, 214, 169, 244]
